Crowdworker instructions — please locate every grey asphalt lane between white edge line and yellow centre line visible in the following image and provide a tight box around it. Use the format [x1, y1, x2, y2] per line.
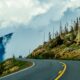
[0, 59, 62, 80]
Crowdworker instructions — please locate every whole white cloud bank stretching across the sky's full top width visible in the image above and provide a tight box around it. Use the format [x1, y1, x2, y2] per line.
[0, 0, 80, 27]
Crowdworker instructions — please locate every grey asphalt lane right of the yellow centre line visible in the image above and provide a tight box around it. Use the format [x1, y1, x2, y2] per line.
[60, 61, 80, 80]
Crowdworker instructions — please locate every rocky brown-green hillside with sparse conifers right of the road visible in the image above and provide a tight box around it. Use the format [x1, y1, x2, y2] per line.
[27, 18, 80, 60]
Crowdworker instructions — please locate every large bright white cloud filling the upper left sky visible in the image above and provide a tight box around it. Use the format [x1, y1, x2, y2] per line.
[0, 0, 51, 27]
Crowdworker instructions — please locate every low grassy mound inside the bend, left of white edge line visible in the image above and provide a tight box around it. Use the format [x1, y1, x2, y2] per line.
[0, 58, 32, 77]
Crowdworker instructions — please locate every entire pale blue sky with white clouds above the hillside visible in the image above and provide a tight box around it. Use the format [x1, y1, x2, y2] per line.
[0, 0, 80, 57]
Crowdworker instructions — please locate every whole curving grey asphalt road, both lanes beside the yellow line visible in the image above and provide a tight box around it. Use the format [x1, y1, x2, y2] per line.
[0, 59, 80, 80]
